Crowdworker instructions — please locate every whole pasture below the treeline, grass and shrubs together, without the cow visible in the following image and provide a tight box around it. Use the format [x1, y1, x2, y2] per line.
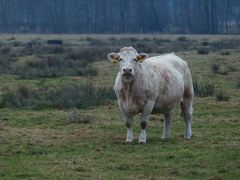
[0, 34, 240, 180]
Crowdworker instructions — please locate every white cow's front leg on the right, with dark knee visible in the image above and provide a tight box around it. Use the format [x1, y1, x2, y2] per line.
[138, 101, 155, 144]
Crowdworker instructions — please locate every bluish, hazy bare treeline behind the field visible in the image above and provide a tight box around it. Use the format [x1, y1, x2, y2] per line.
[0, 0, 240, 34]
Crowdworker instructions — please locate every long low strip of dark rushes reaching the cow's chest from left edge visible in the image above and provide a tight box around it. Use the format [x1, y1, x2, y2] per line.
[0, 82, 116, 109]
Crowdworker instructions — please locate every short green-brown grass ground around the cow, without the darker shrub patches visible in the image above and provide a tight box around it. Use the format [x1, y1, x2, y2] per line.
[0, 35, 240, 180]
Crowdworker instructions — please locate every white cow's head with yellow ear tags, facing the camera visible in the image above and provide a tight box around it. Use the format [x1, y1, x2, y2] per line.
[107, 47, 148, 83]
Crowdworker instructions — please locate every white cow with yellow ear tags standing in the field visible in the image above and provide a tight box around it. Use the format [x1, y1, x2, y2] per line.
[108, 47, 194, 144]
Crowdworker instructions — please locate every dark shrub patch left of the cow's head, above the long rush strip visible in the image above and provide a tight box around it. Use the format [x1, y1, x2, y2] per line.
[14, 48, 106, 79]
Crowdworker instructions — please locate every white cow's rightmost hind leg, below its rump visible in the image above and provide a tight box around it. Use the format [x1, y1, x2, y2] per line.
[181, 97, 193, 139]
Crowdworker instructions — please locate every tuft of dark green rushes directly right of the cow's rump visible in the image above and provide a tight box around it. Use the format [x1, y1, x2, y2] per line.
[193, 80, 215, 97]
